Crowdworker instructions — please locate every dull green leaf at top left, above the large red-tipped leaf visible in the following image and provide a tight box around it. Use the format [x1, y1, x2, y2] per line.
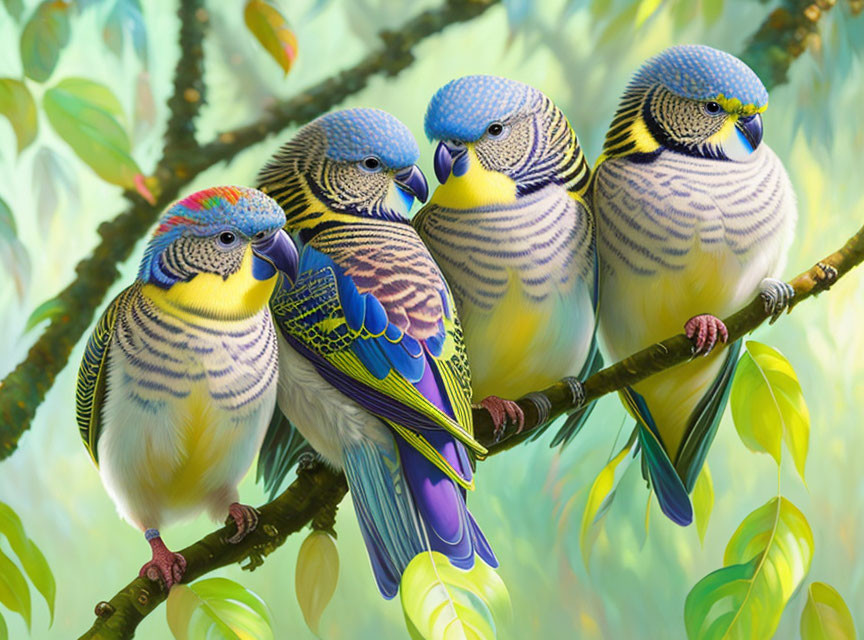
[20, 0, 72, 82]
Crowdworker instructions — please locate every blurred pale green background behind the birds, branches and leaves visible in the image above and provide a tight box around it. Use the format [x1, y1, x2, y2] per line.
[0, 0, 864, 639]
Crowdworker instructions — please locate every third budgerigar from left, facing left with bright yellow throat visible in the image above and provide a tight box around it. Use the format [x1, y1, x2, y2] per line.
[413, 75, 602, 444]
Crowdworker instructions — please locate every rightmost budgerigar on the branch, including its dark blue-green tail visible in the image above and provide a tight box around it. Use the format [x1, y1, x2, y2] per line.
[591, 45, 797, 525]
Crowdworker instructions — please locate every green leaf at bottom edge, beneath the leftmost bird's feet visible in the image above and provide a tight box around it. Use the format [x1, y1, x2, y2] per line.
[166, 578, 273, 640]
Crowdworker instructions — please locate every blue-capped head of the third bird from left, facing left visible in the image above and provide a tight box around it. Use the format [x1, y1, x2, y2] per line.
[425, 75, 588, 204]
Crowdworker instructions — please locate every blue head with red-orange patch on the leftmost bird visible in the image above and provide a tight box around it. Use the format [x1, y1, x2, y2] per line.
[138, 187, 297, 289]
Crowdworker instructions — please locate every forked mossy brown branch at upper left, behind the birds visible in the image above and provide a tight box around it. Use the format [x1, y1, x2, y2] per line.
[0, 0, 499, 460]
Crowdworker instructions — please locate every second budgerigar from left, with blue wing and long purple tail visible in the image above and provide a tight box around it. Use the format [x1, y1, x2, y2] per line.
[258, 109, 506, 637]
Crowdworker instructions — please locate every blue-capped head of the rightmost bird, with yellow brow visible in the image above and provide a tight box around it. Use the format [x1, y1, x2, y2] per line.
[604, 45, 768, 161]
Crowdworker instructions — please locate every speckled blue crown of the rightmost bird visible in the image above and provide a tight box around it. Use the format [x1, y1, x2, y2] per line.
[633, 44, 768, 113]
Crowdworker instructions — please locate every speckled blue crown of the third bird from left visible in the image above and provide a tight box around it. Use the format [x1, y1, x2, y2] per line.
[425, 75, 539, 142]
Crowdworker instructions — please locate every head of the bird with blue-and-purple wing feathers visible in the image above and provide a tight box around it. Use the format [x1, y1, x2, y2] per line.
[258, 108, 428, 230]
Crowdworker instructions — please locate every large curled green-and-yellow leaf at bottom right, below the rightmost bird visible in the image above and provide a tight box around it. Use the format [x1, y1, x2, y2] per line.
[684, 497, 813, 640]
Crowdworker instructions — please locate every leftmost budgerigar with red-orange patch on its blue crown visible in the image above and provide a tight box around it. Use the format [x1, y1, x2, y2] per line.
[76, 187, 296, 588]
